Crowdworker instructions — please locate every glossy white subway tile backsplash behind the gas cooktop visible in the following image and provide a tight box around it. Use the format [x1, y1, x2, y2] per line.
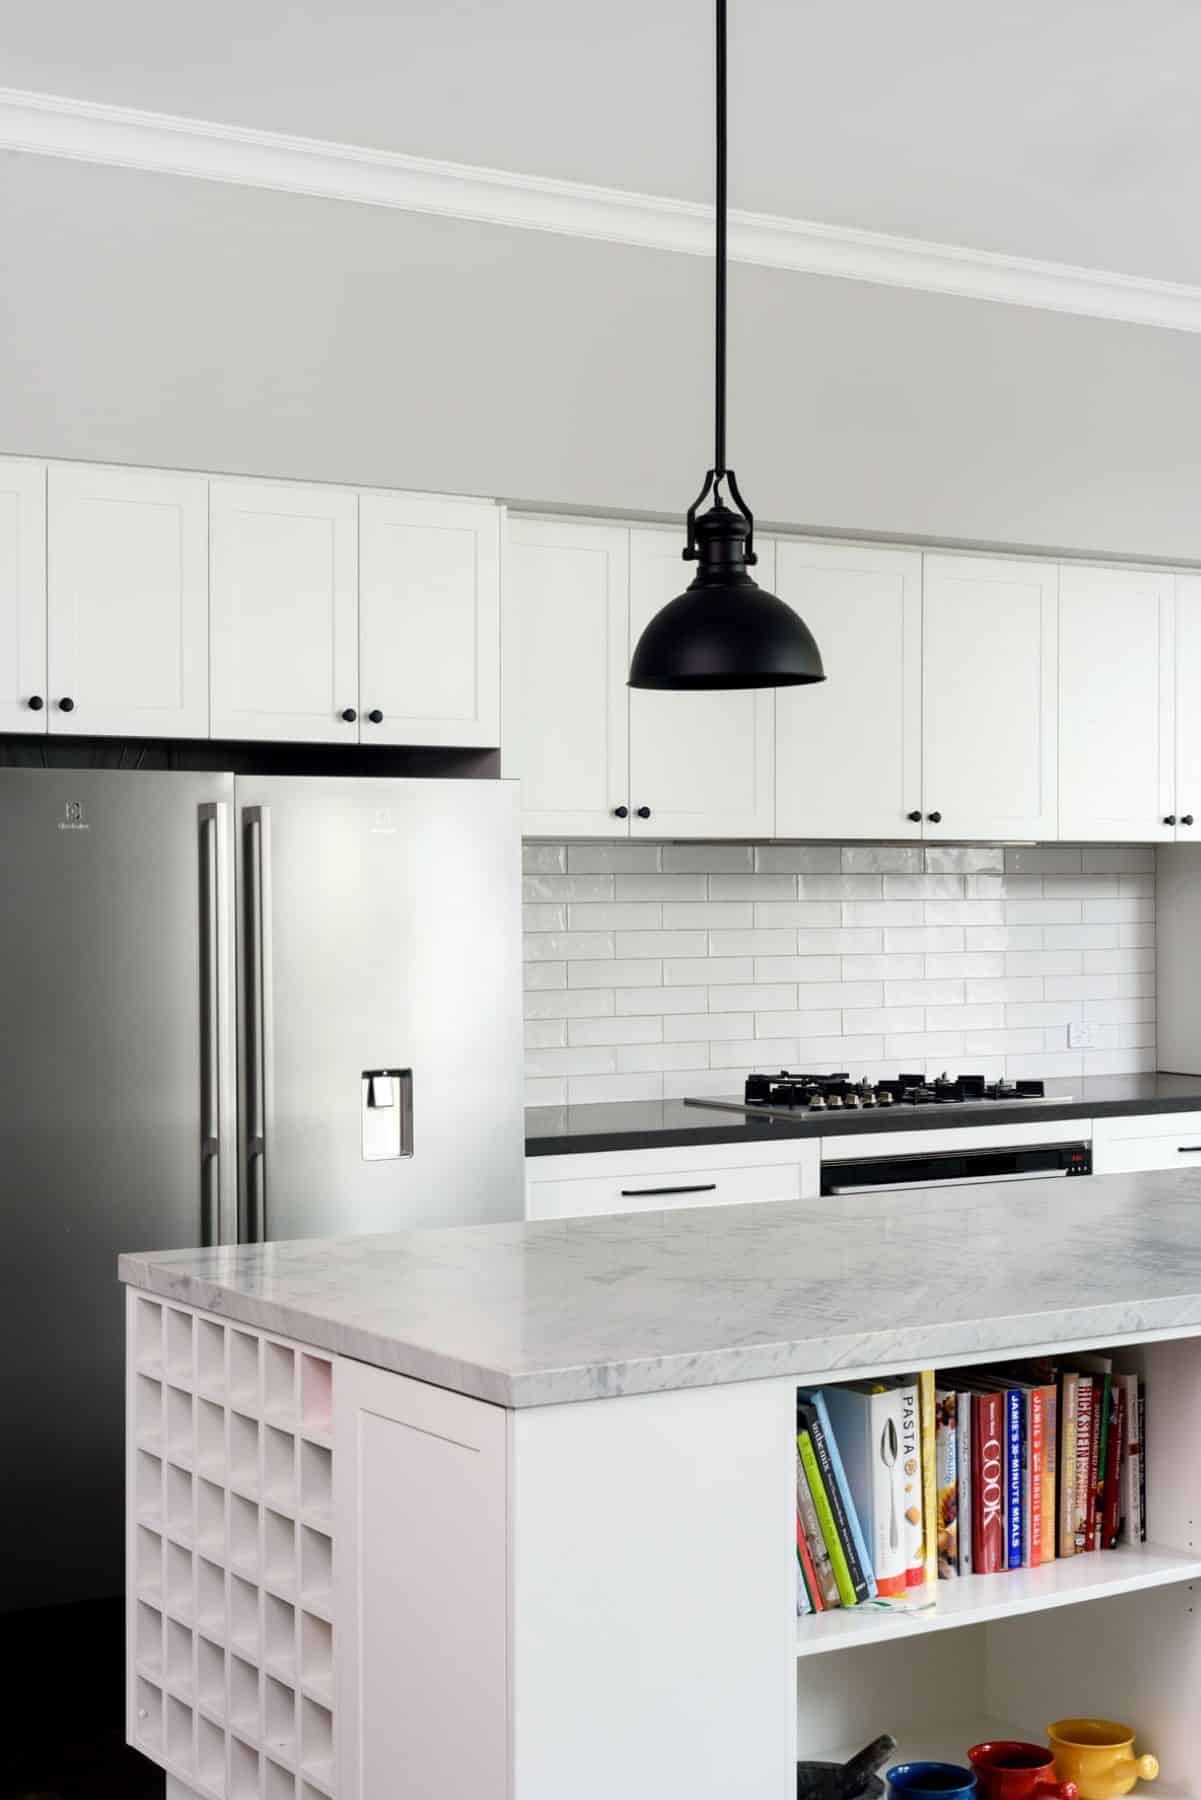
[522, 842, 1156, 1105]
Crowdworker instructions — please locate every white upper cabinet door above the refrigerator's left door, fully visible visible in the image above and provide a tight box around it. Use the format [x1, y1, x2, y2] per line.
[47, 464, 209, 738]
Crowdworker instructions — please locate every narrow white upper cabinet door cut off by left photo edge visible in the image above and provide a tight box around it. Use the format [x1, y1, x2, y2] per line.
[0, 457, 49, 731]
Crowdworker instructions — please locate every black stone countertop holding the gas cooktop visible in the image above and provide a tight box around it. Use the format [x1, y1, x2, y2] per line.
[526, 1075, 1201, 1156]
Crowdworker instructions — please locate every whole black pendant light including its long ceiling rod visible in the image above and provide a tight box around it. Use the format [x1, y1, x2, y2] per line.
[630, 0, 826, 693]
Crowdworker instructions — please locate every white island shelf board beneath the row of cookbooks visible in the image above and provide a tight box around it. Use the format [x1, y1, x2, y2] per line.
[796, 1544, 1201, 1656]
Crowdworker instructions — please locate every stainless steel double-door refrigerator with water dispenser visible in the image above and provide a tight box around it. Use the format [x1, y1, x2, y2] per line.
[0, 769, 522, 1611]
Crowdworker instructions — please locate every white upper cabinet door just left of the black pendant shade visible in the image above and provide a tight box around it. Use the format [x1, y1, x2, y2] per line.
[502, 518, 630, 837]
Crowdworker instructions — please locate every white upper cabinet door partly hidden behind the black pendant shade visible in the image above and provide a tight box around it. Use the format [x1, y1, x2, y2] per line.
[630, 529, 776, 837]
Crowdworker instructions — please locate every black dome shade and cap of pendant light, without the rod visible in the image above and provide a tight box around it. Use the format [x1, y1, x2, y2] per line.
[630, 499, 826, 693]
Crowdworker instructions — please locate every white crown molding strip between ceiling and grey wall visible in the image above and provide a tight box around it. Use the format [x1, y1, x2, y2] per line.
[0, 88, 1201, 331]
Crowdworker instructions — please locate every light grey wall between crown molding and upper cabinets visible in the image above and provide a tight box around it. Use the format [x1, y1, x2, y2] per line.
[0, 157, 1201, 562]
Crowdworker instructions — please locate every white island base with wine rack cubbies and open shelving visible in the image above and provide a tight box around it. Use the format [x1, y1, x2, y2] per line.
[128, 1291, 1201, 1800]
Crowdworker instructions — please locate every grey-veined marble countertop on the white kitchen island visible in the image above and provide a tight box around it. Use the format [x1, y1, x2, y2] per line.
[121, 1170, 1201, 1408]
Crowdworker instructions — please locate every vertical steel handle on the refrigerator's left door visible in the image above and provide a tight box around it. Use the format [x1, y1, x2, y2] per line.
[200, 801, 229, 1244]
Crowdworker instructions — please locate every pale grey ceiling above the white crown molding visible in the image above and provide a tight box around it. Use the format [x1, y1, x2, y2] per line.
[9, 0, 1201, 283]
